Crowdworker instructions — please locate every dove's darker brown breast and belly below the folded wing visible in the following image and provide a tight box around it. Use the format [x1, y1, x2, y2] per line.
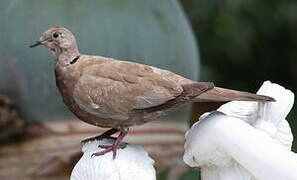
[55, 59, 144, 128]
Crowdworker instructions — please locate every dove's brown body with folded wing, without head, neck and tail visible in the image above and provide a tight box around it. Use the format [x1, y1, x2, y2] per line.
[56, 55, 213, 128]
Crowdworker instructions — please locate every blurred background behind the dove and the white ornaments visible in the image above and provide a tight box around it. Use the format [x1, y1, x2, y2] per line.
[0, 0, 297, 180]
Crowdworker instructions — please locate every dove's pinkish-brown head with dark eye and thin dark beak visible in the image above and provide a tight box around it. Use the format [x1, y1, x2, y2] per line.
[30, 27, 79, 57]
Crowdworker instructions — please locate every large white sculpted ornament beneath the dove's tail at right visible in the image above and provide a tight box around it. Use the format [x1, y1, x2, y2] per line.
[183, 81, 297, 180]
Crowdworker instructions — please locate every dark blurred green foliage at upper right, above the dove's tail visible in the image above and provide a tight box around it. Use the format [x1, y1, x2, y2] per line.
[181, 0, 297, 152]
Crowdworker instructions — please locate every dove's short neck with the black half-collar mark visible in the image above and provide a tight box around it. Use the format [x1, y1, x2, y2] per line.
[53, 46, 80, 66]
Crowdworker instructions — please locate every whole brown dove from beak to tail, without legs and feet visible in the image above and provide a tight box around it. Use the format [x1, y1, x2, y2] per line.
[31, 27, 273, 158]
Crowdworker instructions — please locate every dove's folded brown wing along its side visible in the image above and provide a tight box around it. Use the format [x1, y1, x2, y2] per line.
[73, 60, 183, 120]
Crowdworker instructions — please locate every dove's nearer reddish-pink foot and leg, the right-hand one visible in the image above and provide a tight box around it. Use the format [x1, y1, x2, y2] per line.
[92, 131, 128, 159]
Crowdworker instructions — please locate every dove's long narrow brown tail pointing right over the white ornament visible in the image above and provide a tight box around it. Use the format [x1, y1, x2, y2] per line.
[194, 87, 275, 102]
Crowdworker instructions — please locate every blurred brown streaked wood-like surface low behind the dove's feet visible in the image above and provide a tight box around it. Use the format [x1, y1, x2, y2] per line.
[0, 120, 188, 180]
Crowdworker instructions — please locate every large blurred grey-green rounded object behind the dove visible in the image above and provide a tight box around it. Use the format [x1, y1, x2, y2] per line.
[0, 0, 199, 121]
